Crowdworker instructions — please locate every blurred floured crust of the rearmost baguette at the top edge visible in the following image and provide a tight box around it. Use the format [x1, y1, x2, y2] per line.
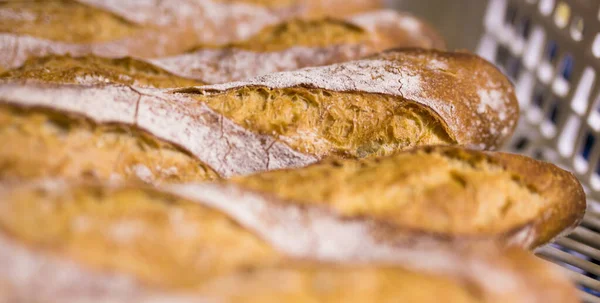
[79, 0, 382, 40]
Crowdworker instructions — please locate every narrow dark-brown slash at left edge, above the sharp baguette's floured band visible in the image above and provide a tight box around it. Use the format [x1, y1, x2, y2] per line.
[0, 55, 203, 88]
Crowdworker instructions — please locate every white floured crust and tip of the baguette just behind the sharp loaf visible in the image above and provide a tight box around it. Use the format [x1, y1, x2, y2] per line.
[0, 9, 443, 84]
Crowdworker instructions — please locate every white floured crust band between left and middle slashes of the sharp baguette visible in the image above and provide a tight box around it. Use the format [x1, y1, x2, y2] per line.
[0, 82, 316, 178]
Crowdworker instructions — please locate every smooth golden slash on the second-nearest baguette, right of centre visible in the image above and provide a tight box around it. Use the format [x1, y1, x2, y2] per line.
[233, 150, 551, 236]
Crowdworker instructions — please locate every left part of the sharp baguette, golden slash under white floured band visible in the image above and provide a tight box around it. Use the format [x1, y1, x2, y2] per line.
[0, 83, 316, 183]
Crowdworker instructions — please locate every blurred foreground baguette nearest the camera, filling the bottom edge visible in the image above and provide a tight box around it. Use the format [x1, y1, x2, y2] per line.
[0, 181, 577, 303]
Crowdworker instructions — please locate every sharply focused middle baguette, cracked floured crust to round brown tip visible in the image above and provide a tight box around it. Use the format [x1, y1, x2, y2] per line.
[0, 50, 518, 182]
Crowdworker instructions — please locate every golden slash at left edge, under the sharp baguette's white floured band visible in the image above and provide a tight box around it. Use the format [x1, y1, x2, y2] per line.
[0, 105, 218, 184]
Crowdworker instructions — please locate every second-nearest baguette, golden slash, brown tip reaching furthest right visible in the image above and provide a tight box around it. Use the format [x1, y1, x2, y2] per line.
[176, 146, 586, 248]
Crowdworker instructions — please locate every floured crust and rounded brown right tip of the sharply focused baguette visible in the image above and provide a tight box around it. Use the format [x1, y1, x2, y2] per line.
[179, 49, 519, 149]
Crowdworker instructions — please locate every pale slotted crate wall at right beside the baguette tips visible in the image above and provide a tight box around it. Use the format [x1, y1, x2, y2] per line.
[477, 0, 600, 302]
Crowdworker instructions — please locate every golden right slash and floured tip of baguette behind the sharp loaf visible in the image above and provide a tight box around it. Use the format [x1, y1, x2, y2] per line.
[218, 10, 444, 53]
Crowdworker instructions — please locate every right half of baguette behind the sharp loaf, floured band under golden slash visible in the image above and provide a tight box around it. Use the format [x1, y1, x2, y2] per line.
[147, 10, 444, 84]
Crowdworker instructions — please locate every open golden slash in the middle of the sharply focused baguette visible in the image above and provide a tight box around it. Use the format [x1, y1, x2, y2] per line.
[194, 86, 453, 158]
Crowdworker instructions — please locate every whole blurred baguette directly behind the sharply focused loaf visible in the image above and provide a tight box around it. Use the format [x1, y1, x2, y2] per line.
[0, 10, 443, 87]
